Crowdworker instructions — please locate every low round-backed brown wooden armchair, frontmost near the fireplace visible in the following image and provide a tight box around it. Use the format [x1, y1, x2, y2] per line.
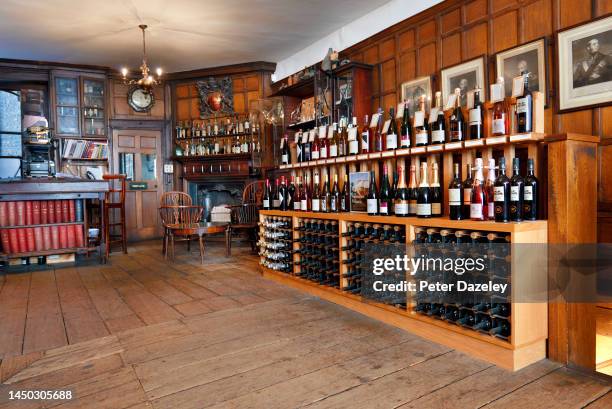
[159, 205, 204, 263]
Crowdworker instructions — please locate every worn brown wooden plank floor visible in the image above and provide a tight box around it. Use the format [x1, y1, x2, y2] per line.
[0, 242, 612, 409]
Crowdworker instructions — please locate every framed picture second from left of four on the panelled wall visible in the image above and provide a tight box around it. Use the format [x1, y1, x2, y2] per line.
[440, 55, 488, 106]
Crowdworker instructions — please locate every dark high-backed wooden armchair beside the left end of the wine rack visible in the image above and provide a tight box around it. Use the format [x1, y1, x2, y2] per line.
[227, 180, 265, 255]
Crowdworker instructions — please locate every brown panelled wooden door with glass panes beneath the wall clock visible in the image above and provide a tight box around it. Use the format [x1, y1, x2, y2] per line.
[113, 129, 163, 241]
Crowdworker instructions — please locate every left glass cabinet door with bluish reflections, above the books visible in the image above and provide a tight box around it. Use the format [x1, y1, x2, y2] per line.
[55, 77, 81, 136]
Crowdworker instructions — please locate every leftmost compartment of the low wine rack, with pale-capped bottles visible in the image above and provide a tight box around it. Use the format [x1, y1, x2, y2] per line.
[258, 217, 293, 274]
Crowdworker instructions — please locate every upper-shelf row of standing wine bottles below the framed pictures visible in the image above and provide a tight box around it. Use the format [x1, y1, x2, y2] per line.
[281, 75, 533, 164]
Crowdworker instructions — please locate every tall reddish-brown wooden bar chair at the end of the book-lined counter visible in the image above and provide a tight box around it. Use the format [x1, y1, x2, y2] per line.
[102, 175, 127, 258]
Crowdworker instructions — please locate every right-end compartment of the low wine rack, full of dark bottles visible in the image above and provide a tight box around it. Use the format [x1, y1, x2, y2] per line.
[412, 227, 511, 341]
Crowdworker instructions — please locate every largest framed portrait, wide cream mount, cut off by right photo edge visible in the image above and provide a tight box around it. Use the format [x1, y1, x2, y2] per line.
[557, 15, 612, 112]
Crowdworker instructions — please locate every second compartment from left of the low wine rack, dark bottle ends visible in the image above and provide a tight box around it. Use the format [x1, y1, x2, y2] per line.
[294, 219, 340, 288]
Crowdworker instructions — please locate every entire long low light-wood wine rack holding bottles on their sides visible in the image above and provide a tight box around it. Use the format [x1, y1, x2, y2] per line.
[259, 210, 548, 370]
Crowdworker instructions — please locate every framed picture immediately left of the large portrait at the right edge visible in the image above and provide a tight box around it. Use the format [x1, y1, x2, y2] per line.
[495, 38, 548, 99]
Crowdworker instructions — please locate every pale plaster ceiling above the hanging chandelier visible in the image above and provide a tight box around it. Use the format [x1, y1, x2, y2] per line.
[0, 0, 389, 72]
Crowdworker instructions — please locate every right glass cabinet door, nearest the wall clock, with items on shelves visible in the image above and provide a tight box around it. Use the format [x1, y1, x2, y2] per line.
[81, 78, 106, 136]
